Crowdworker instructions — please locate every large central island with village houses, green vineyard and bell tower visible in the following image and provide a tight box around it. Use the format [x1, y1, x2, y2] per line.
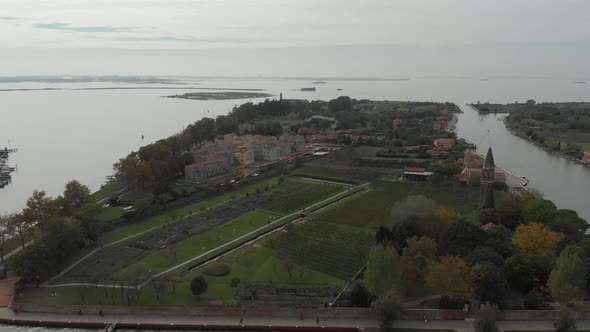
[0, 96, 590, 332]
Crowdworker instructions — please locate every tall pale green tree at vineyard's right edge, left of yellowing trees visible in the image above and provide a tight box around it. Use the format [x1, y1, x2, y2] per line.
[365, 246, 401, 294]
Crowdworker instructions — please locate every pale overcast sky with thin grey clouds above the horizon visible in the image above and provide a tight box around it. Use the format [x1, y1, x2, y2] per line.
[0, 0, 590, 78]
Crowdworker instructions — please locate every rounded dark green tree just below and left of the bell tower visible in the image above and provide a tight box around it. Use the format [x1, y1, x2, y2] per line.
[438, 221, 487, 256]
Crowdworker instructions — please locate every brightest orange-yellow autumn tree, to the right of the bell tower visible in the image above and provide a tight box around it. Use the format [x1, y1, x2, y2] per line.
[512, 223, 561, 256]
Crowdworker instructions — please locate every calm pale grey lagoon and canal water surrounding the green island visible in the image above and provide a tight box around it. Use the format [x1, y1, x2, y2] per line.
[0, 78, 590, 220]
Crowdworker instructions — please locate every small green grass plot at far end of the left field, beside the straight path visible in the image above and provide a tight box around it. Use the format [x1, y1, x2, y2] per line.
[261, 180, 344, 214]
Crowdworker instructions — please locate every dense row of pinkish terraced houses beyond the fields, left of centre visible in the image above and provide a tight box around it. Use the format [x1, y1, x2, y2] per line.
[184, 134, 305, 183]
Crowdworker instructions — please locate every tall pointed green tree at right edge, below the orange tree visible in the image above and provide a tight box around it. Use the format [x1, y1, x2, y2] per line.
[548, 248, 586, 302]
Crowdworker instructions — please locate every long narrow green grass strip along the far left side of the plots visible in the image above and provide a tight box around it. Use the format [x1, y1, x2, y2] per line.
[100, 177, 278, 243]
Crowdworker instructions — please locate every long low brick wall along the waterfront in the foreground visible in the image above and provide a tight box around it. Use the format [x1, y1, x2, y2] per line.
[18, 304, 465, 320]
